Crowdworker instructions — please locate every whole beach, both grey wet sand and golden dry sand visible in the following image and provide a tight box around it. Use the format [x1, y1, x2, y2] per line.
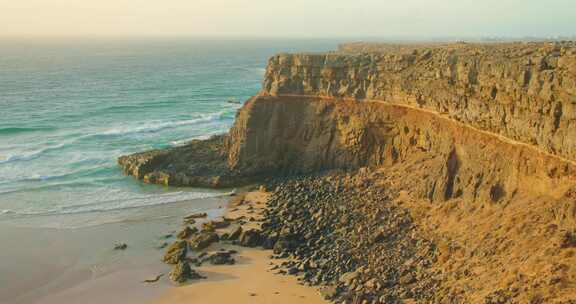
[0, 191, 326, 304]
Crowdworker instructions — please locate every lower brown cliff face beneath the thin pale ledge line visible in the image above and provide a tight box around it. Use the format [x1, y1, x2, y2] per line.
[228, 96, 576, 203]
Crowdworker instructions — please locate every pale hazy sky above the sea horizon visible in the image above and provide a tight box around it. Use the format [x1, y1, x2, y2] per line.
[0, 0, 576, 37]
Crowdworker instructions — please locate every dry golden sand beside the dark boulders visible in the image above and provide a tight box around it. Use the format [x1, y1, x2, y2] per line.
[152, 191, 328, 304]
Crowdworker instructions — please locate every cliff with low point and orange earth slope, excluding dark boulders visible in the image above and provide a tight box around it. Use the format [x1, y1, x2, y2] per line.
[119, 43, 576, 303]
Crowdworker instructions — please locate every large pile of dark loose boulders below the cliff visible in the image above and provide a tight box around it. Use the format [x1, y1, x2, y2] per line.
[260, 174, 437, 303]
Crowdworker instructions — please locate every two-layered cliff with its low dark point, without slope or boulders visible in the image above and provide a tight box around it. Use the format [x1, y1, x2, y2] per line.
[119, 43, 576, 200]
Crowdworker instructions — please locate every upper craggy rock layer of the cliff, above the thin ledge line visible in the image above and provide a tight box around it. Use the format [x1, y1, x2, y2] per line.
[264, 43, 576, 160]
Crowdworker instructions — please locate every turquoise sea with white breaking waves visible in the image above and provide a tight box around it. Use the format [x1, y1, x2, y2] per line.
[0, 39, 337, 226]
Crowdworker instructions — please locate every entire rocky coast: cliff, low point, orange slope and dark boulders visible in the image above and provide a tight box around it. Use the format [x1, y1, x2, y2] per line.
[119, 42, 576, 303]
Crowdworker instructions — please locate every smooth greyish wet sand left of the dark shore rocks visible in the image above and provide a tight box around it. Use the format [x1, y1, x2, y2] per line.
[0, 197, 229, 304]
